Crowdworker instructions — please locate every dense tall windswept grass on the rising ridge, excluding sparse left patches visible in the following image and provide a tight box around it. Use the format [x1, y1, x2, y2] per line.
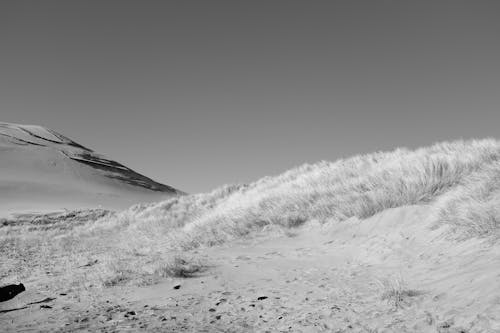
[114, 139, 500, 249]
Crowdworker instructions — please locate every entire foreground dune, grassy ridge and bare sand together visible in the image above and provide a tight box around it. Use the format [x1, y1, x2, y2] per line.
[0, 139, 500, 333]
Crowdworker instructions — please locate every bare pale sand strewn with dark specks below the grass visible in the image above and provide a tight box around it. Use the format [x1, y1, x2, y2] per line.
[0, 206, 500, 332]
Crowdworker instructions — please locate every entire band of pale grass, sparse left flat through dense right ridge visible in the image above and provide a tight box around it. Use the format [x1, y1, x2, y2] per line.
[0, 139, 500, 285]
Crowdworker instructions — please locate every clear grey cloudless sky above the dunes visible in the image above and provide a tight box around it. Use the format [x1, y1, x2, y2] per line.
[0, 0, 500, 193]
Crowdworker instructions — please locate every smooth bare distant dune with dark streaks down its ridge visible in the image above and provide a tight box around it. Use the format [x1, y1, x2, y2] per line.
[0, 123, 180, 215]
